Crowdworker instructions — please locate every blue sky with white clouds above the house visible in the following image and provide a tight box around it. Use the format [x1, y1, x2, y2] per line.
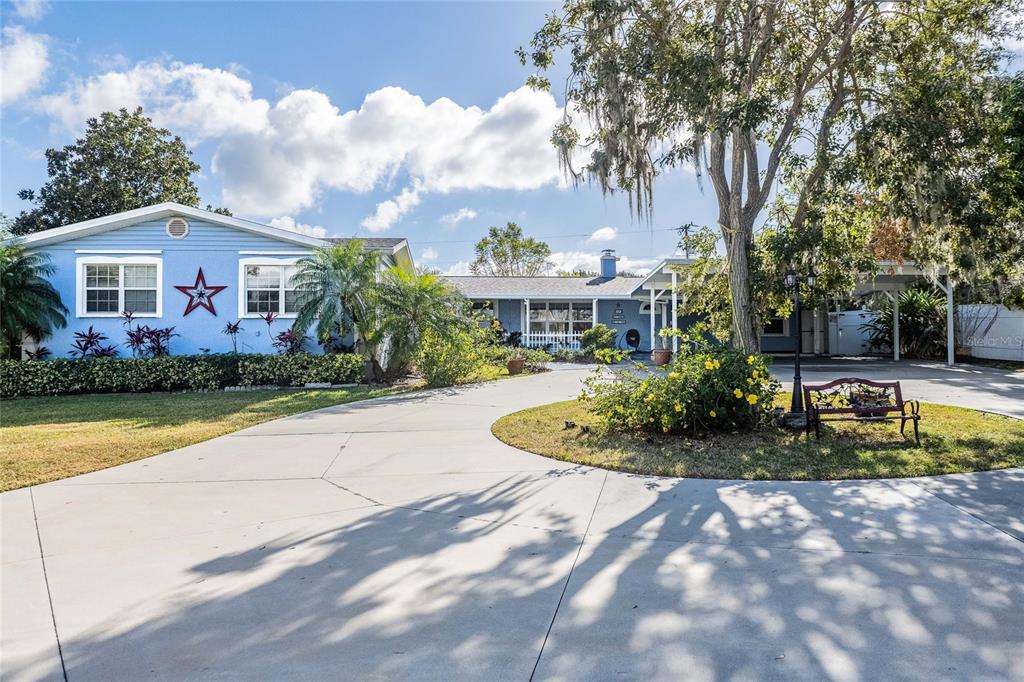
[0, 0, 715, 271]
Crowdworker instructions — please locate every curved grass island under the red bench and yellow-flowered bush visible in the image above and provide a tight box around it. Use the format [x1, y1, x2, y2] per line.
[493, 393, 1024, 480]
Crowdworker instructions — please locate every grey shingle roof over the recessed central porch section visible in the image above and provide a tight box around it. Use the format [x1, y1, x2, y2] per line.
[445, 275, 643, 298]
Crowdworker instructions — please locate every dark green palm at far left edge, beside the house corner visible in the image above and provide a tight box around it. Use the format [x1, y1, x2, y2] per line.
[0, 244, 68, 357]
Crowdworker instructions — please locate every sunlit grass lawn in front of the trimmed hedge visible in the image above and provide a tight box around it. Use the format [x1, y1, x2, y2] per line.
[0, 386, 402, 491]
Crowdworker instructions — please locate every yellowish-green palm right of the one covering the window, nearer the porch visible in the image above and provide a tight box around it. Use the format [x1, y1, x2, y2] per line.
[377, 267, 475, 375]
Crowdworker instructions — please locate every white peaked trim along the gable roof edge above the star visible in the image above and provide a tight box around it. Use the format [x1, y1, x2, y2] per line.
[20, 202, 329, 247]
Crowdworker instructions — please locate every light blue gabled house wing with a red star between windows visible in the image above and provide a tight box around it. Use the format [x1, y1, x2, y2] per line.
[22, 203, 414, 357]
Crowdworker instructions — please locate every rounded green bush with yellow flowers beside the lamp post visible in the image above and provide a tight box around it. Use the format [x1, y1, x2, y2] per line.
[580, 332, 780, 434]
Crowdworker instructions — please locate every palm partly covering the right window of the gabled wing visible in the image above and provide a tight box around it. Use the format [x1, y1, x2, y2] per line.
[292, 240, 380, 374]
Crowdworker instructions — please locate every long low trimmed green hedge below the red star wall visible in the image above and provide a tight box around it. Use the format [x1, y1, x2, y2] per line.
[0, 353, 365, 398]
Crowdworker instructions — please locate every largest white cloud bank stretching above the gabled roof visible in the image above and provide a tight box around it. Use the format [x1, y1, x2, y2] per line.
[38, 61, 564, 219]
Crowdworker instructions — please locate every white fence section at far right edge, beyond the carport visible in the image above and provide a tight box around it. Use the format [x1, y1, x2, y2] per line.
[956, 304, 1024, 363]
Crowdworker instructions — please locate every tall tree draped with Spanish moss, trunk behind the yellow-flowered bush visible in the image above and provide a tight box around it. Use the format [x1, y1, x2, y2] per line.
[519, 0, 1008, 350]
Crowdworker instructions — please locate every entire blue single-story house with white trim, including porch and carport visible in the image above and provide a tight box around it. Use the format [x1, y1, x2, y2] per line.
[23, 203, 953, 364]
